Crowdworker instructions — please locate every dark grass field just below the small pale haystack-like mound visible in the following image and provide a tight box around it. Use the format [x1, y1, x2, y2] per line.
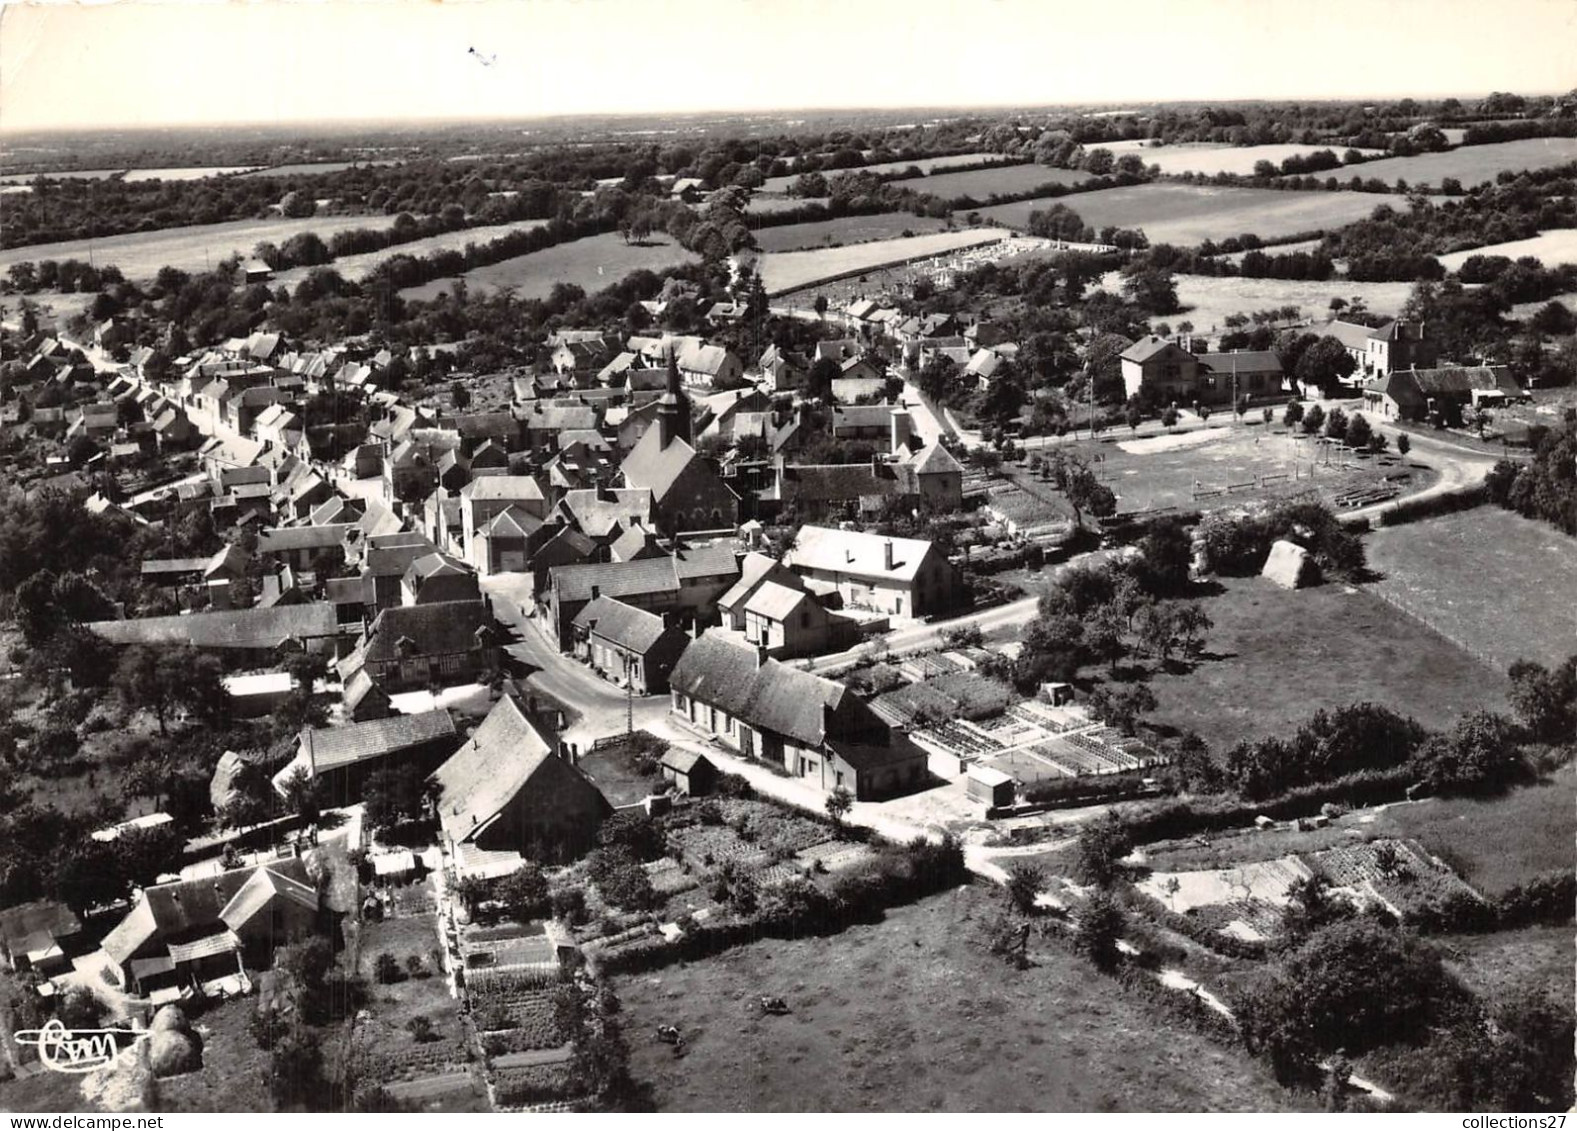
[1150, 577, 1501, 760]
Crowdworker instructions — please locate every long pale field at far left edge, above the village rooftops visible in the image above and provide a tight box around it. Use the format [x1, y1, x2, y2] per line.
[0, 215, 394, 279]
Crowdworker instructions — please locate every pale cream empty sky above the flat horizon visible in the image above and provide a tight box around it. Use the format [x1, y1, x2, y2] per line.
[0, 0, 1577, 133]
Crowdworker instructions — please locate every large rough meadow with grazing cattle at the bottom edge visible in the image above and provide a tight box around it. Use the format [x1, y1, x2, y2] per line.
[615, 887, 1296, 1112]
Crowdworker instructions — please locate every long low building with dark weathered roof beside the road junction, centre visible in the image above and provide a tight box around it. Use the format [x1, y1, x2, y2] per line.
[669, 631, 927, 801]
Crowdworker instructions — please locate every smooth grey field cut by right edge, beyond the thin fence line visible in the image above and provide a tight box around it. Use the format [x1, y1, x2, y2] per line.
[1367, 506, 1577, 670]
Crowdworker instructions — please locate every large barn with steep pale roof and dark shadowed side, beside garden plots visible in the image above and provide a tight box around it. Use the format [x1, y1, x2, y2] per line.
[431, 686, 612, 860]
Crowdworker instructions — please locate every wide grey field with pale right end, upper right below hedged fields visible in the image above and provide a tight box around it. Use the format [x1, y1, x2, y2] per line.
[981, 183, 1385, 248]
